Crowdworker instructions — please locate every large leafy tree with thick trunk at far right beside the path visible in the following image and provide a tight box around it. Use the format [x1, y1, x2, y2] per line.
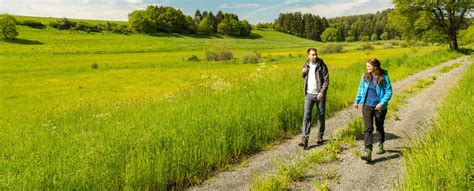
[389, 0, 474, 50]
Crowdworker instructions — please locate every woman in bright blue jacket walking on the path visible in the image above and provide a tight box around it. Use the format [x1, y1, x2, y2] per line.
[354, 58, 392, 161]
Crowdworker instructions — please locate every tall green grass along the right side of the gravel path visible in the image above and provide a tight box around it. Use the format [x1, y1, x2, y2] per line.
[403, 62, 474, 190]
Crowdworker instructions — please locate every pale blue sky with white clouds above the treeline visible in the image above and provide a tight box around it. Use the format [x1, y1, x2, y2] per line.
[0, 0, 393, 24]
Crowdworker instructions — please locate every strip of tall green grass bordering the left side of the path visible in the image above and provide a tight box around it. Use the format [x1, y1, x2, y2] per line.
[0, 49, 459, 189]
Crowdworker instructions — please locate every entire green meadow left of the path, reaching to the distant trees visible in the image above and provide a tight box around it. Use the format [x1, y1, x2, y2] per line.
[0, 18, 461, 190]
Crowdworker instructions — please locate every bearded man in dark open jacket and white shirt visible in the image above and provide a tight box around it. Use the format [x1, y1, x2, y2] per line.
[298, 48, 329, 149]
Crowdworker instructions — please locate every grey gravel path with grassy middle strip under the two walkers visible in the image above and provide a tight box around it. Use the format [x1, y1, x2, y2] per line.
[189, 56, 471, 190]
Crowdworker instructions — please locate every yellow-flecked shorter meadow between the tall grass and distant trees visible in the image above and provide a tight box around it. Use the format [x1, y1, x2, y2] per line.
[0, 23, 440, 120]
